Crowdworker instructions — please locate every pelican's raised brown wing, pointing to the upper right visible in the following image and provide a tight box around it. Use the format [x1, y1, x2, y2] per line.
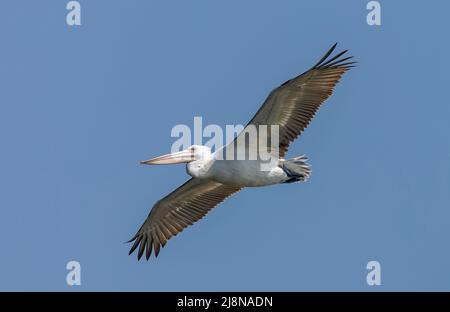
[234, 44, 355, 158]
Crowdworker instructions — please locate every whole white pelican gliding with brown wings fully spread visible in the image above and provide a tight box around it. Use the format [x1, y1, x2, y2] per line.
[129, 44, 356, 260]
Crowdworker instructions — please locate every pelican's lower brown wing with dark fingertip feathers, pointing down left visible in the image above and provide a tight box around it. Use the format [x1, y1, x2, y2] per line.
[129, 178, 240, 260]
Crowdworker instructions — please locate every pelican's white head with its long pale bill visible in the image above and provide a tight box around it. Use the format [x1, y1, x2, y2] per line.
[141, 145, 211, 165]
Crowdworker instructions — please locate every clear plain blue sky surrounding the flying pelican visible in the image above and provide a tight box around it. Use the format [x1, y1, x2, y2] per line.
[0, 0, 450, 291]
